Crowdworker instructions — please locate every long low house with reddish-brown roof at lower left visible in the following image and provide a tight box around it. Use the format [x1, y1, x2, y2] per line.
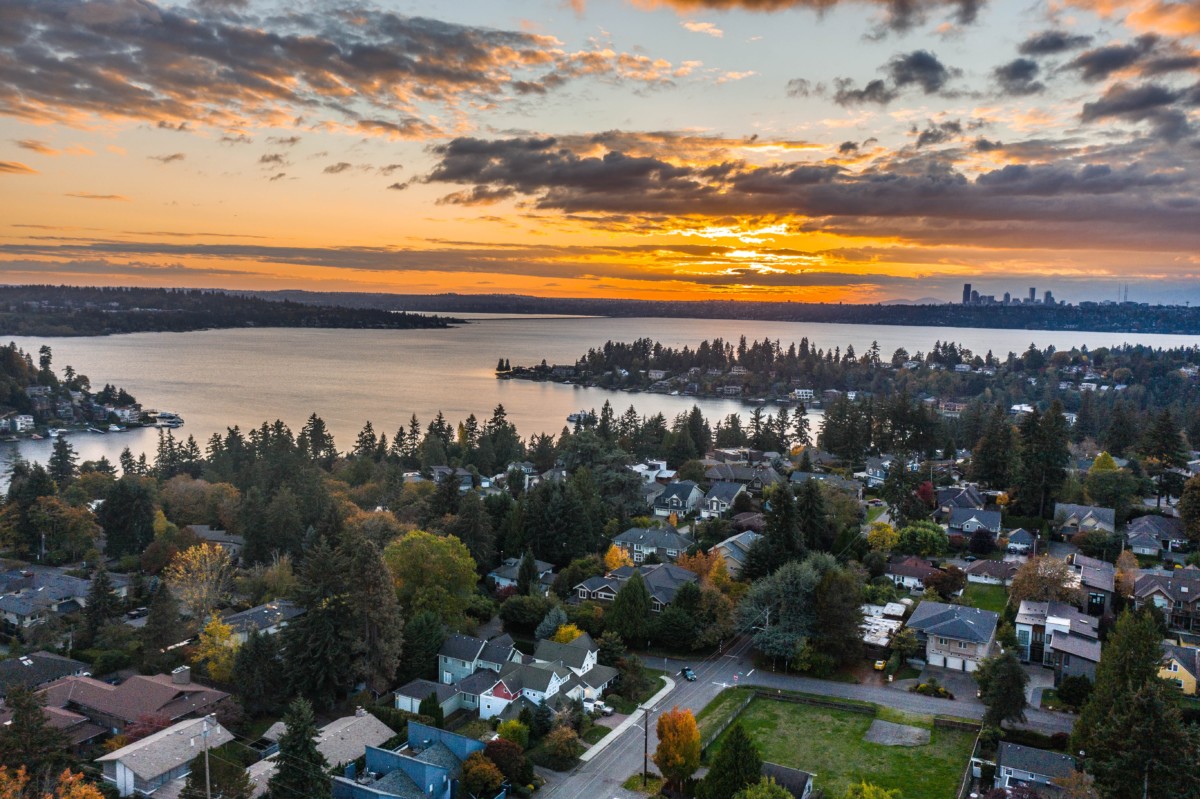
[38, 666, 229, 734]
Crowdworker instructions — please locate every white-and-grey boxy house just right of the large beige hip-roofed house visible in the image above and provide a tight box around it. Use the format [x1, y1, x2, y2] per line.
[1014, 600, 1100, 685]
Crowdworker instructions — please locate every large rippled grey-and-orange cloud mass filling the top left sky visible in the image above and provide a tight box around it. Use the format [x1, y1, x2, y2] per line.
[0, 0, 662, 137]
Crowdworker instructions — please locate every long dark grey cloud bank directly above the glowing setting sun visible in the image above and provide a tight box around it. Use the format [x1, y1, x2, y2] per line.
[424, 131, 1200, 242]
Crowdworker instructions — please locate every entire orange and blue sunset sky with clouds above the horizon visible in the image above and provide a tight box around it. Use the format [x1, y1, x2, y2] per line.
[0, 0, 1200, 302]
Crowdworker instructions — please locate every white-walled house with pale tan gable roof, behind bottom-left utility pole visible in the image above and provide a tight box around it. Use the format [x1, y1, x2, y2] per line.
[96, 716, 233, 797]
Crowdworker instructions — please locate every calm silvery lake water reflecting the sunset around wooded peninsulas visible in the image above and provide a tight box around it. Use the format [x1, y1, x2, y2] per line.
[0, 314, 1196, 470]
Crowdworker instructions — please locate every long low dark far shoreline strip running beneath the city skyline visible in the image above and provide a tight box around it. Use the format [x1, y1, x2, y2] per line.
[238, 290, 1200, 335]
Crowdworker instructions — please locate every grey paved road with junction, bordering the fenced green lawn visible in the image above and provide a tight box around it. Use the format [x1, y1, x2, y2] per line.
[540, 638, 1073, 799]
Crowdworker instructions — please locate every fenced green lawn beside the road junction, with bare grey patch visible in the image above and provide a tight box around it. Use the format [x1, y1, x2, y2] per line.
[718, 699, 976, 799]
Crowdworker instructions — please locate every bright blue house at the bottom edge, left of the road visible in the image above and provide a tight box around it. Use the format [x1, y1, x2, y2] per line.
[334, 721, 508, 799]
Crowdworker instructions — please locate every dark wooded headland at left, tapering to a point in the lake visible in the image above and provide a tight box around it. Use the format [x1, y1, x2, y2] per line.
[0, 286, 462, 336]
